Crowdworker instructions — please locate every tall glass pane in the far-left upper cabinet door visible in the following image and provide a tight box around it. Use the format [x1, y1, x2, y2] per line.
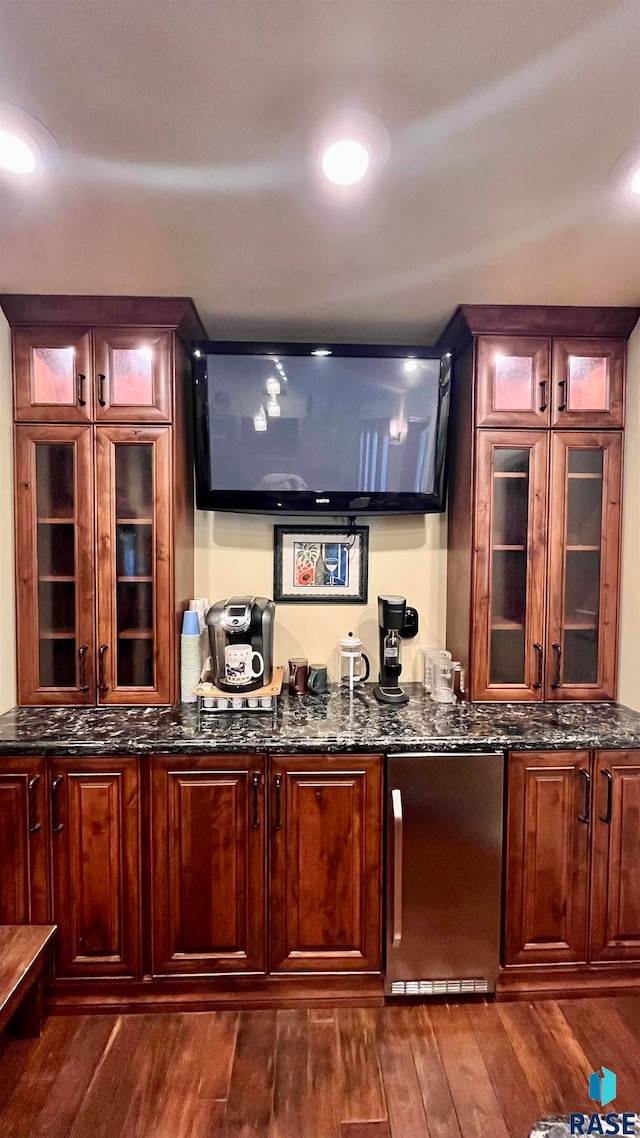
[35, 443, 76, 687]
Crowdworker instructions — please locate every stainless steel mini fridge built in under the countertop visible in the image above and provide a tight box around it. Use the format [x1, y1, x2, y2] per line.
[385, 753, 504, 996]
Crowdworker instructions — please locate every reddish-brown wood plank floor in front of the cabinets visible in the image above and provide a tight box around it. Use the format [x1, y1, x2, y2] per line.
[0, 998, 640, 1138]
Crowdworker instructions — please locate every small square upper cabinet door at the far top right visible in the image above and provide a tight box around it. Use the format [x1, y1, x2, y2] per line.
[553, 340, 626, 428]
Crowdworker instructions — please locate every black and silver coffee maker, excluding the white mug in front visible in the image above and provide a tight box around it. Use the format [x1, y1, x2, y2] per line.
[206, 596, 276, 694]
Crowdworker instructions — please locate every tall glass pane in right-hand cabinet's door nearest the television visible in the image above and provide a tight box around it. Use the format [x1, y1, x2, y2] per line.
[490, 447, 531, 684]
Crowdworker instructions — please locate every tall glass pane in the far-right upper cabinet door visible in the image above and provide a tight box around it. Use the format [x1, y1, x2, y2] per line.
[561, 447, 602, 684]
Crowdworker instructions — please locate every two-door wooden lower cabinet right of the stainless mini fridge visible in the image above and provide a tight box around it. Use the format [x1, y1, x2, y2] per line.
[504, 751, 640, 966]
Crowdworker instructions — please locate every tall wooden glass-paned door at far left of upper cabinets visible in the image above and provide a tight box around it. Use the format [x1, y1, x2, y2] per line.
[16, 426, 96, 704]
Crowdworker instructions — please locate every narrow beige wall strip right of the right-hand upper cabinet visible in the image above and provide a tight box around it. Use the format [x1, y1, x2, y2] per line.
[618, 321, 640, 711]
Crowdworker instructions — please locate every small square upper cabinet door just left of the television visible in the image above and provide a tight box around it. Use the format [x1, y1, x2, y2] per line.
[93, 328, 172, 423]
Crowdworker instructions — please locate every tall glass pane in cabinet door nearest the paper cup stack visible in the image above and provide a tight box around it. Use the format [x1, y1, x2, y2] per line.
[115, 444, 155, 687]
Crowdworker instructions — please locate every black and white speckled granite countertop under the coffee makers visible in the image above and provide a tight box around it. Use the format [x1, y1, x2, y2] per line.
[0, 684, 640, 754]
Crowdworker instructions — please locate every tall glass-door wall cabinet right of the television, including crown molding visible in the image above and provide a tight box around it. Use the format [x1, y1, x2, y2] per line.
[441, 305, 639, 701]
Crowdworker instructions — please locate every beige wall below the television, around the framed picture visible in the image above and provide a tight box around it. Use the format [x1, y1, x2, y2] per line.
[191, 512, 446, 679]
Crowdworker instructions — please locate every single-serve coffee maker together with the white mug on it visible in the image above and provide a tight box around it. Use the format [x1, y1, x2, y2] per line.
[206, 596, 276, 695]
